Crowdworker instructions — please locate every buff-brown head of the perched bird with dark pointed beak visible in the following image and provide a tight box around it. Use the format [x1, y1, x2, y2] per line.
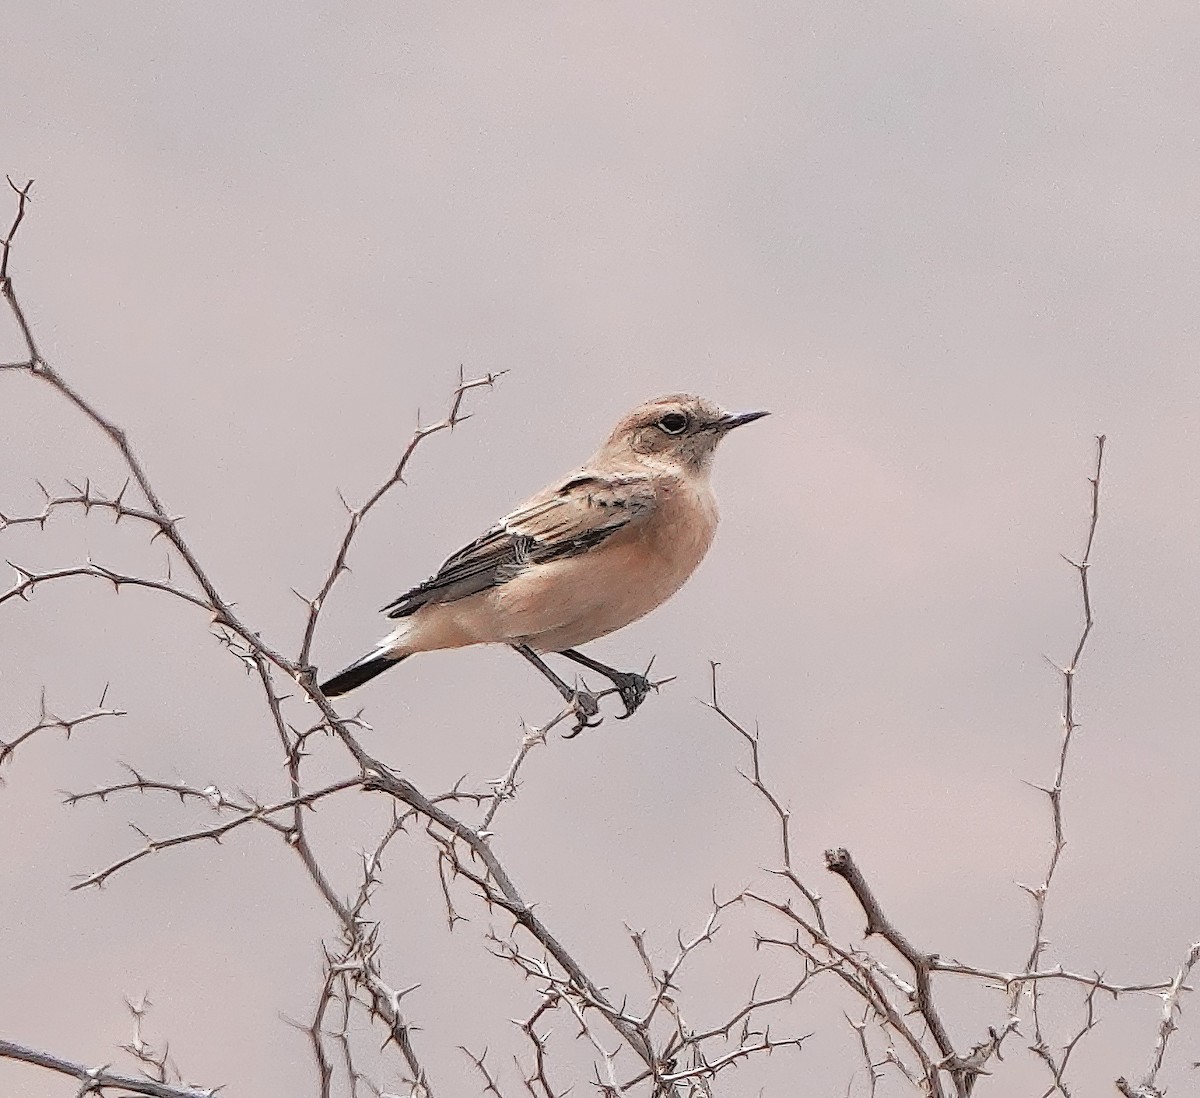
[601, 392, 768, 470]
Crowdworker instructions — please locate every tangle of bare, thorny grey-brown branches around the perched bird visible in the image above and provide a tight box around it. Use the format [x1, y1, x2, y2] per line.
[0, 180, 1200, 1098]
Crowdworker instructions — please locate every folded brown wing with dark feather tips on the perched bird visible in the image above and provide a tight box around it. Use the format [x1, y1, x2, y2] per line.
[383, 469, 655, 618]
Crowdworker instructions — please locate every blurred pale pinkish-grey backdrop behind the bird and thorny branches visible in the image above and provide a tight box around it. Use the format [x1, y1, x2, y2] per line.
[0, 0, 1200, 1096]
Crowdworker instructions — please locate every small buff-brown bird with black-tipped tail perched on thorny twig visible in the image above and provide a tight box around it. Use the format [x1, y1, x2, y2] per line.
[320, 394, 768, 734]
